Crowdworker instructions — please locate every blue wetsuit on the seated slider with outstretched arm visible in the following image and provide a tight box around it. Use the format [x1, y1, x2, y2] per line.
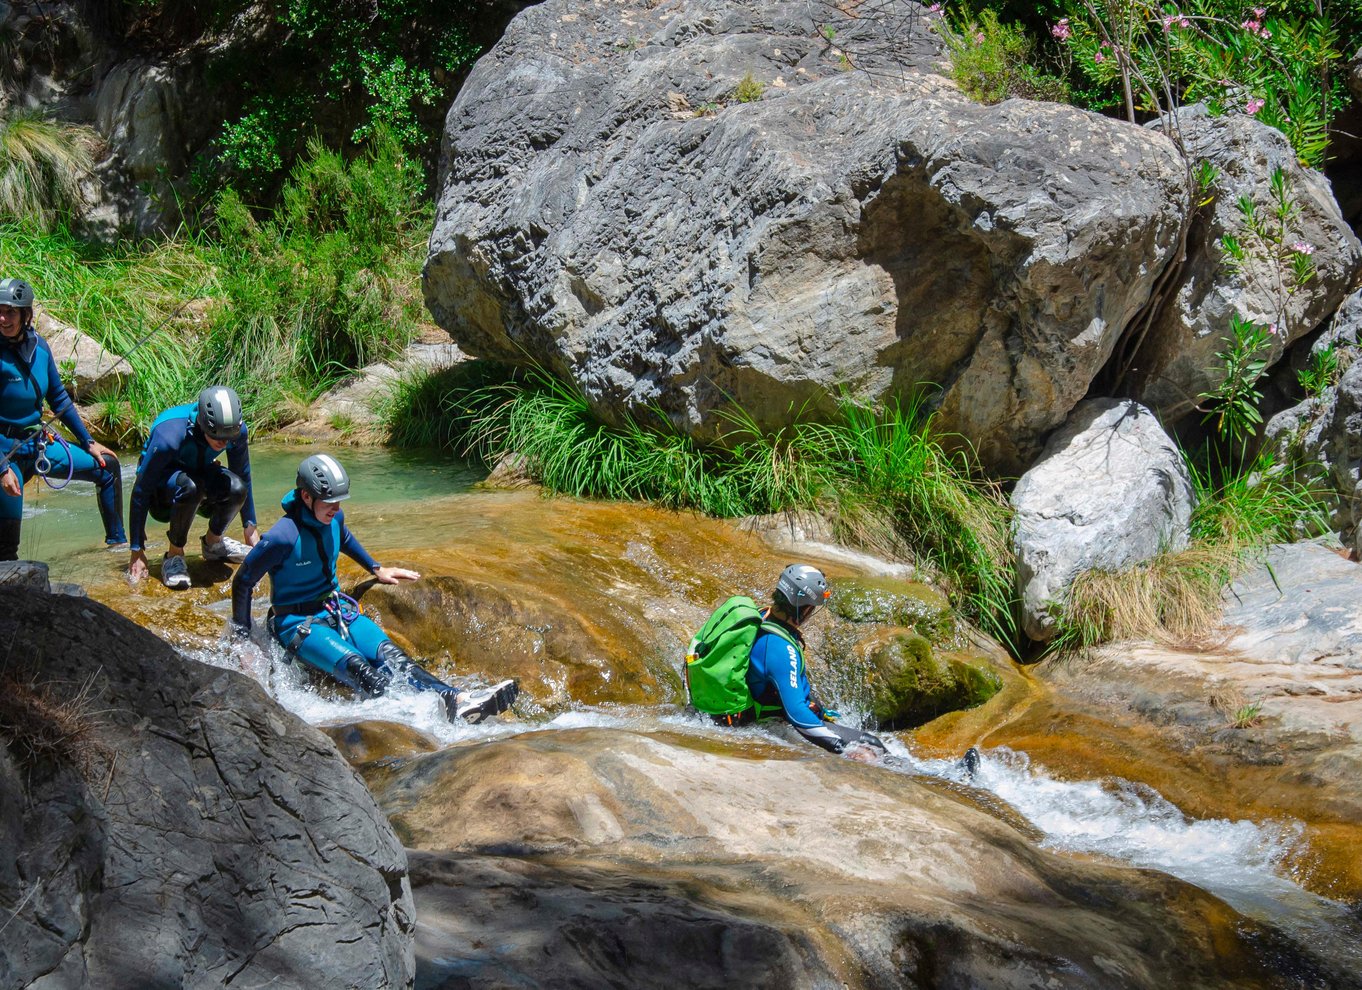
[232, 490, 456, 697]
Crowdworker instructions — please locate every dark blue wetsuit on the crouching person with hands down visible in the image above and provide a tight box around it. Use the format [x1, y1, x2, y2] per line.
[128, 402, 256, 550]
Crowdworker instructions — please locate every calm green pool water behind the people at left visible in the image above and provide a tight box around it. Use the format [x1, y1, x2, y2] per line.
[19, 443, 473, 580]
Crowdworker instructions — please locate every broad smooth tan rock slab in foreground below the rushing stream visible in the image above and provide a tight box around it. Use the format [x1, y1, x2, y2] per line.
[376, 729, 1318, 987]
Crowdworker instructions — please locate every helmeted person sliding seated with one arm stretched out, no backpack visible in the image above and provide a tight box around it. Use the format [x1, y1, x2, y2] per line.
[232, 453, 518, 722]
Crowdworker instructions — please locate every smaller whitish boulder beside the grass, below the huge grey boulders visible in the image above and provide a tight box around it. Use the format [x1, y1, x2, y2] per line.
[1012, 399, 1194, 640]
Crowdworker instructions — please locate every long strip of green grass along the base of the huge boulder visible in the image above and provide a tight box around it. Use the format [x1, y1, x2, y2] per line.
[385, 362, 1015, 641]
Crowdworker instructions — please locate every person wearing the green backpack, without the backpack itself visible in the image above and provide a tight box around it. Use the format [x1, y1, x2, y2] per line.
[746, 564, 884, 753]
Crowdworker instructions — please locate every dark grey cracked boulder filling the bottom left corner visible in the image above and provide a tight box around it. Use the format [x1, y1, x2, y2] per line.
[0, 590, 414, 990]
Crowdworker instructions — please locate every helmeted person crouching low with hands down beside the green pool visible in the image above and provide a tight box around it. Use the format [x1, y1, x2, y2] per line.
[128, 385, 260, 588]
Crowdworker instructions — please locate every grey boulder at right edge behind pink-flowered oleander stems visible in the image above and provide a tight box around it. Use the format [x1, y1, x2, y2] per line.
[1128, 105, 1362, 424]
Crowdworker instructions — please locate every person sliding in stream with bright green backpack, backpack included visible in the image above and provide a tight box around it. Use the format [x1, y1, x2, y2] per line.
[686, 564, 885, 760]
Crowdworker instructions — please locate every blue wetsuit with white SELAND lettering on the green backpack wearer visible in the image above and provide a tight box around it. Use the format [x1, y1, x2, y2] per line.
[748, 617, 883, 753]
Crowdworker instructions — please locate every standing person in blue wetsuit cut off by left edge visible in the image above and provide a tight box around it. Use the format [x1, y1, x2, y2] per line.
[0, 278, 127, 560]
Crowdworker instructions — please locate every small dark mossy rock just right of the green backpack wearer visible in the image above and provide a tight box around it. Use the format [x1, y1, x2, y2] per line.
[865, 629, 1002, 729]
